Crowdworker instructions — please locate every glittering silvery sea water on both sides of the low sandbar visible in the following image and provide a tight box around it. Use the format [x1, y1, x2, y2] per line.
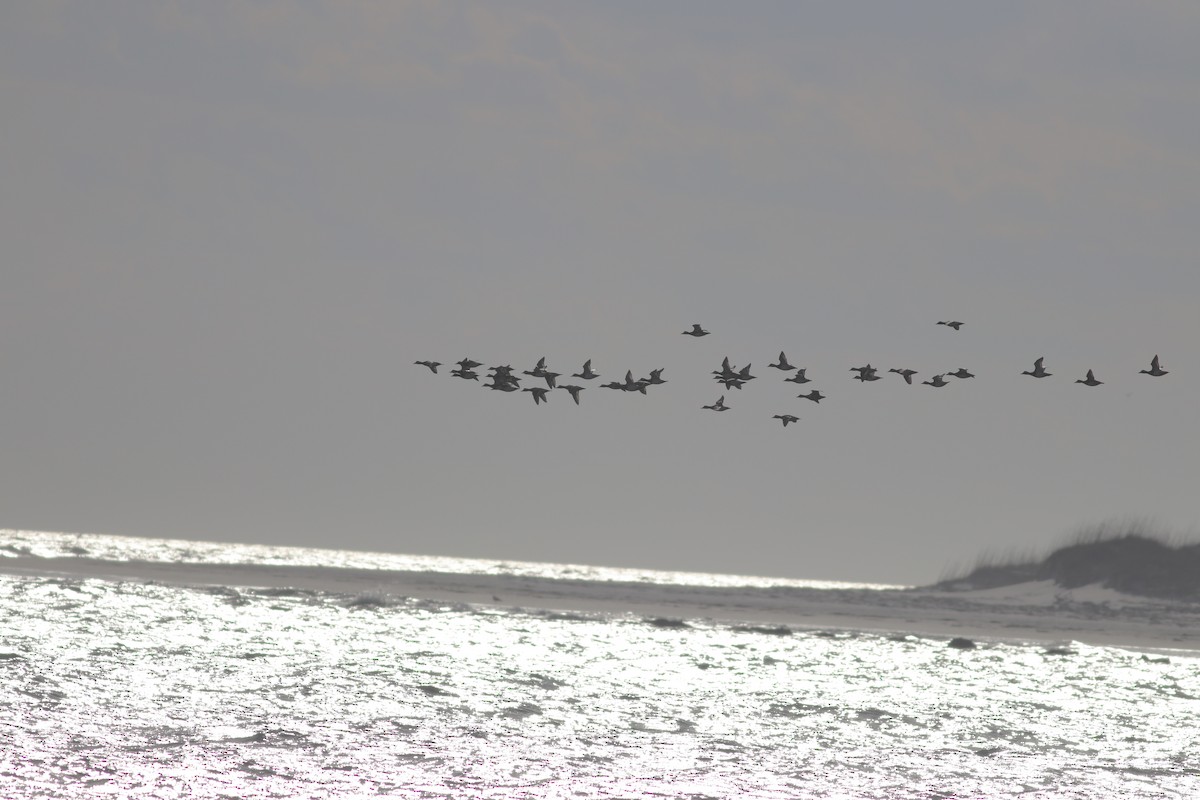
[0, 535, 1200, 799]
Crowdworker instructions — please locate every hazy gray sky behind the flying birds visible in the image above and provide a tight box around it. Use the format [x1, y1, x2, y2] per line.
[0, 0, 1200, 582]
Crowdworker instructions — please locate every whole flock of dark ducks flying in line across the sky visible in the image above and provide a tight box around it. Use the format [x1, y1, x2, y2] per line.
[414, 320, 1168, 428]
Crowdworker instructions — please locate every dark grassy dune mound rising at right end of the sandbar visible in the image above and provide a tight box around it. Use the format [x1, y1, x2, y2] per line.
[932, 524, 1200, 601]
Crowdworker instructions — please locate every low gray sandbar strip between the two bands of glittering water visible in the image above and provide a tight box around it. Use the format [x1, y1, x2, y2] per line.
[9, 557, 1200, 657]
